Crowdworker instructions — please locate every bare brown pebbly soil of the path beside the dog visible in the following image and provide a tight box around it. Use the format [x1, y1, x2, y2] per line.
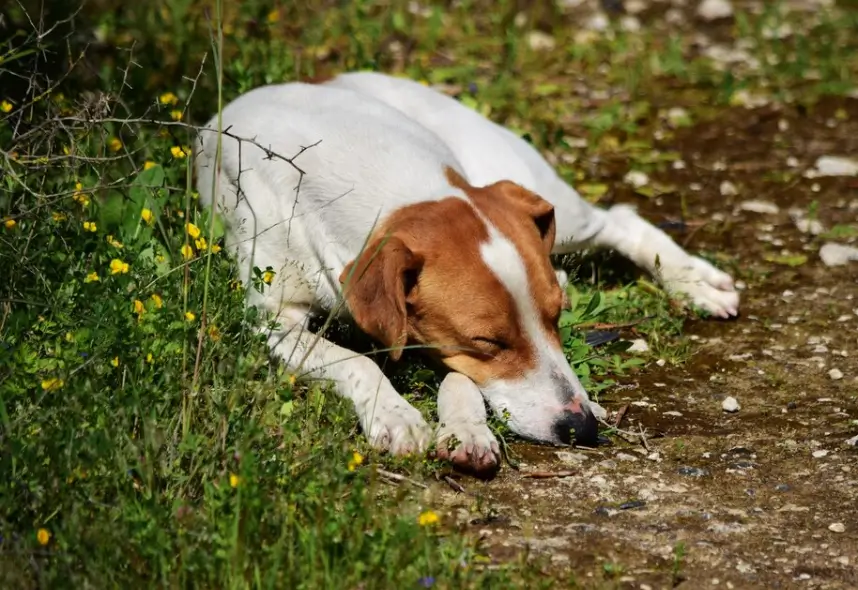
[432, 99, 858, 589]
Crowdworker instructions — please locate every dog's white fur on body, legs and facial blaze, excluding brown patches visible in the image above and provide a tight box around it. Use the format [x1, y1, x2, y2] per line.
[195, 73, 738, 470]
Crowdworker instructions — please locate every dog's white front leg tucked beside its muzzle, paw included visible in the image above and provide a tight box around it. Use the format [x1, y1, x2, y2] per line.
[437, 373, 500, 474]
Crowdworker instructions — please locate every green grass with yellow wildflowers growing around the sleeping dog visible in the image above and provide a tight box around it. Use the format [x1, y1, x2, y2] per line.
[0, 0, 856, 588]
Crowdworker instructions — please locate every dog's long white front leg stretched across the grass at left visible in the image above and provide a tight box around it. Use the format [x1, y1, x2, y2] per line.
[268, 311, 430, 455]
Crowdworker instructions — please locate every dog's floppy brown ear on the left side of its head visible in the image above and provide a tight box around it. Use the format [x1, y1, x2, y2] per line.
[340, 236, 423, 361]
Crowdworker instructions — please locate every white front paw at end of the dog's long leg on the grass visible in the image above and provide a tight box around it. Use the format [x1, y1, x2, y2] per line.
[361, 400, 431, 455]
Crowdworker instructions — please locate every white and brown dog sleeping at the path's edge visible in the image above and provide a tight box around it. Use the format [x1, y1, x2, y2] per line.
[195, 73, 739, 470]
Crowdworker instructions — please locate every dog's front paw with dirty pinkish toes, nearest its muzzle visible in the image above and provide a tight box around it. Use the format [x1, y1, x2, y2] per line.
[436, 422, 500, 474]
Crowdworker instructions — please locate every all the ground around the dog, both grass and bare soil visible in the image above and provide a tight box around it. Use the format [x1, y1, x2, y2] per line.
[0, 0, 858, 590]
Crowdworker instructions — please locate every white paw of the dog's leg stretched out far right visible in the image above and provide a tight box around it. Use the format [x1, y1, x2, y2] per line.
[662, 256, 739, 319]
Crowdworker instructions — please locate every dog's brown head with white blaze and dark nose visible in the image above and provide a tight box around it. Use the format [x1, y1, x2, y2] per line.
[340, 172, 596, 443]
